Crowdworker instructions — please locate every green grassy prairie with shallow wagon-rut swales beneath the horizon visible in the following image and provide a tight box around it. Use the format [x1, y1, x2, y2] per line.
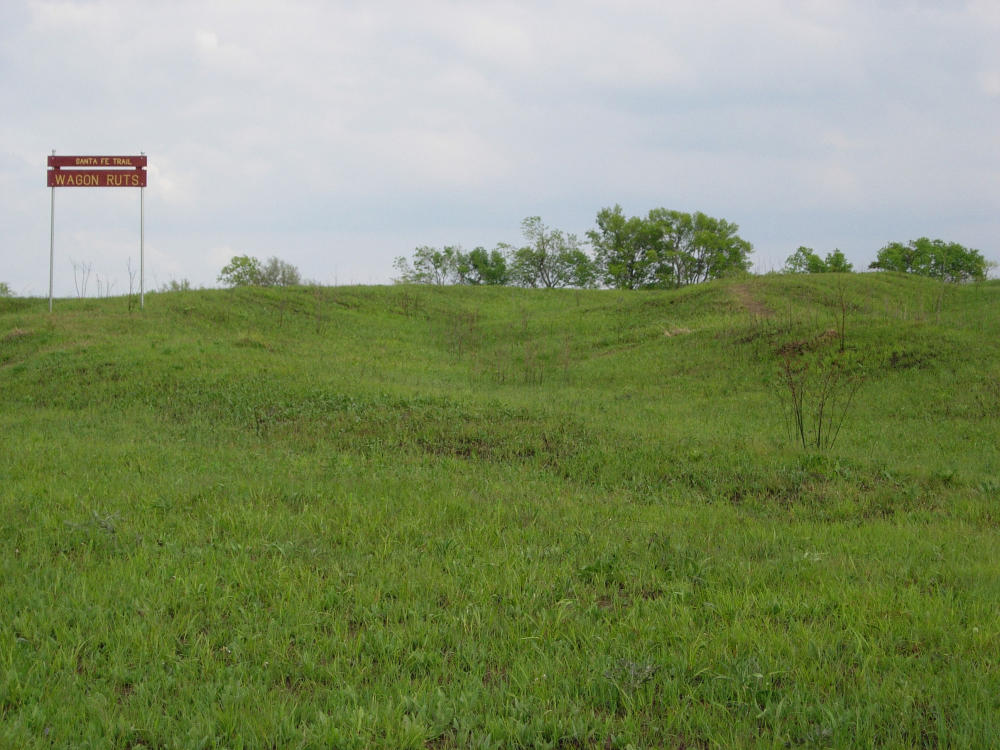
[0, 274, 1000, 748]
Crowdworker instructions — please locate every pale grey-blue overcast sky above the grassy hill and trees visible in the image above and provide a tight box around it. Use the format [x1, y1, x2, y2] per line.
[0, 0, 1000, 296]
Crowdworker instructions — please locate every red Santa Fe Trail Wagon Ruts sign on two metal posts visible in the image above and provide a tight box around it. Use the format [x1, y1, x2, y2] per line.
[46, 151, 146, 312]
